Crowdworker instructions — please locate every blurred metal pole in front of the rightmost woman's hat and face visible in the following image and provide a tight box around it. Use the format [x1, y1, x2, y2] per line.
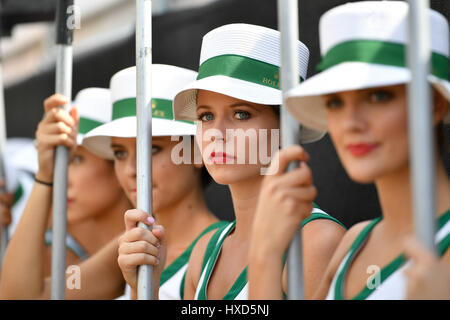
[407, 0, 436, 252]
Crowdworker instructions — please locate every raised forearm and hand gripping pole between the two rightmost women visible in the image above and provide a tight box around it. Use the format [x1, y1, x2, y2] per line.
[248, 146, 317, 300]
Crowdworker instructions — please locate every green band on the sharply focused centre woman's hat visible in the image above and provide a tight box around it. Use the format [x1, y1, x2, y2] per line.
[197, 54, 303, 90]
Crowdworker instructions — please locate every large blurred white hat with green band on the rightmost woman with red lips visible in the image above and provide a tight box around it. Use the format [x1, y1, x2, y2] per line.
[286, 1, 450, 131]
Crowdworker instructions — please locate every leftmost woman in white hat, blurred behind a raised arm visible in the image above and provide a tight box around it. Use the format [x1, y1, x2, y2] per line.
[41, 88, 131, 275]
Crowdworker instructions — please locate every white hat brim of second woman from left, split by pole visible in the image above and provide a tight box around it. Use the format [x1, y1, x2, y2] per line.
[83, 117, 196, 160]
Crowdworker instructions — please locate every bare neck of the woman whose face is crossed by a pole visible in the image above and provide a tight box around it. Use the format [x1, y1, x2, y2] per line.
[155, 185, 218, 250]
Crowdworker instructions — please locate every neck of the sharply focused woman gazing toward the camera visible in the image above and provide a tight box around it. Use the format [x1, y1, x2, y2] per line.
[229, 176, 264, 242]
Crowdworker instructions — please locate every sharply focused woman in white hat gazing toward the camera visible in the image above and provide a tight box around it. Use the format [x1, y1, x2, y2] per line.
[130, 24, 345, 299]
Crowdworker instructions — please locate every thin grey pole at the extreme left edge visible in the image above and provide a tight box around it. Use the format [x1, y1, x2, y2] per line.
[0, 2, 8, 268]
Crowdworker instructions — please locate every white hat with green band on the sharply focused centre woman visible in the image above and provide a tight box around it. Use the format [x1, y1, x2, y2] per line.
[174, 23, 323, 142]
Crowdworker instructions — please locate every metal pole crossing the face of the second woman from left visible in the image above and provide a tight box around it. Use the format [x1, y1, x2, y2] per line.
[136, 0, 153, 300]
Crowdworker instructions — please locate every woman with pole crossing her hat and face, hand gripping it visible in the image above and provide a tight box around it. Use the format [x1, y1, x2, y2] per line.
[84, 64, 223, 300]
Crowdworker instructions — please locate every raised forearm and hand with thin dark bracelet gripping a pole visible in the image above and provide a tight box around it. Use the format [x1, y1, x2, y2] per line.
[0, 95, 78, 299]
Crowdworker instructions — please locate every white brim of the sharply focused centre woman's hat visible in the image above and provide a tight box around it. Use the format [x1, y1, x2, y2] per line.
[173, 75, 325, 143]
